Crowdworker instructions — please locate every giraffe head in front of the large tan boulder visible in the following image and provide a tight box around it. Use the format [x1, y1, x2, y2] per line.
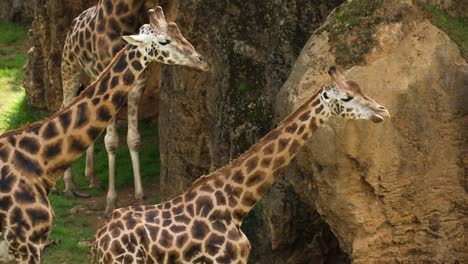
[320, 66, 390, 123]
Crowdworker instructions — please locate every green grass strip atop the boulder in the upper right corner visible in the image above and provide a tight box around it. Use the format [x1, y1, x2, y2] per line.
[419, 3, 468, 59]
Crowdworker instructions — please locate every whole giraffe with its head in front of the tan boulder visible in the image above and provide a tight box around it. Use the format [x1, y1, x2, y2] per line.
[91, 67, 389, 264]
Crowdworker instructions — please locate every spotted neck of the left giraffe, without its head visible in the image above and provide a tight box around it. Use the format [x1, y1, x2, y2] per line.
[0, 45, 148, 190]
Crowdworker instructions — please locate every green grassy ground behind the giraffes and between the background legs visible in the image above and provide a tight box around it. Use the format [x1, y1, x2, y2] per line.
[0, 21, 159, 264]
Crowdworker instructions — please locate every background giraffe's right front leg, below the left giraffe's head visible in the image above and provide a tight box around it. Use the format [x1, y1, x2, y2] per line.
[127, 74, 146, 203]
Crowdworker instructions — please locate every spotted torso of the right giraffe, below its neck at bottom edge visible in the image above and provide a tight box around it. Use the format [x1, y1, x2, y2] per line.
[94, 192, 250, 264]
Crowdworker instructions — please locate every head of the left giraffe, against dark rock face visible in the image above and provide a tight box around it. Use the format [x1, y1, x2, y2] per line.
[123, 6, 209, 71]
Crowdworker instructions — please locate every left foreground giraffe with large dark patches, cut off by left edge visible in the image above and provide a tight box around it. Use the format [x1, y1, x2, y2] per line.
[0, 7, 209, 263]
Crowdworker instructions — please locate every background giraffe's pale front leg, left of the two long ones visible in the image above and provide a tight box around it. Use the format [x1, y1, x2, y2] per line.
[104, 119, 119, 214]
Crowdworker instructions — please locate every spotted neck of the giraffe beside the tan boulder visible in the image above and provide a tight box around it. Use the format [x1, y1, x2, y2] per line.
[186, 86, 331, 224]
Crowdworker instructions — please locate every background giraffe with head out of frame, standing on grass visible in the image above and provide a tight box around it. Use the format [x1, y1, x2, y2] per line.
[61, 0, 162, 212]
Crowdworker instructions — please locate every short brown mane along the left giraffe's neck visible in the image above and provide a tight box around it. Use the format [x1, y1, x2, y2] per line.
[0, 44, 129, 138]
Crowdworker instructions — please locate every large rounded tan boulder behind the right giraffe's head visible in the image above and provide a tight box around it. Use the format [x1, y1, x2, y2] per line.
[267, 0, 468, 263]
